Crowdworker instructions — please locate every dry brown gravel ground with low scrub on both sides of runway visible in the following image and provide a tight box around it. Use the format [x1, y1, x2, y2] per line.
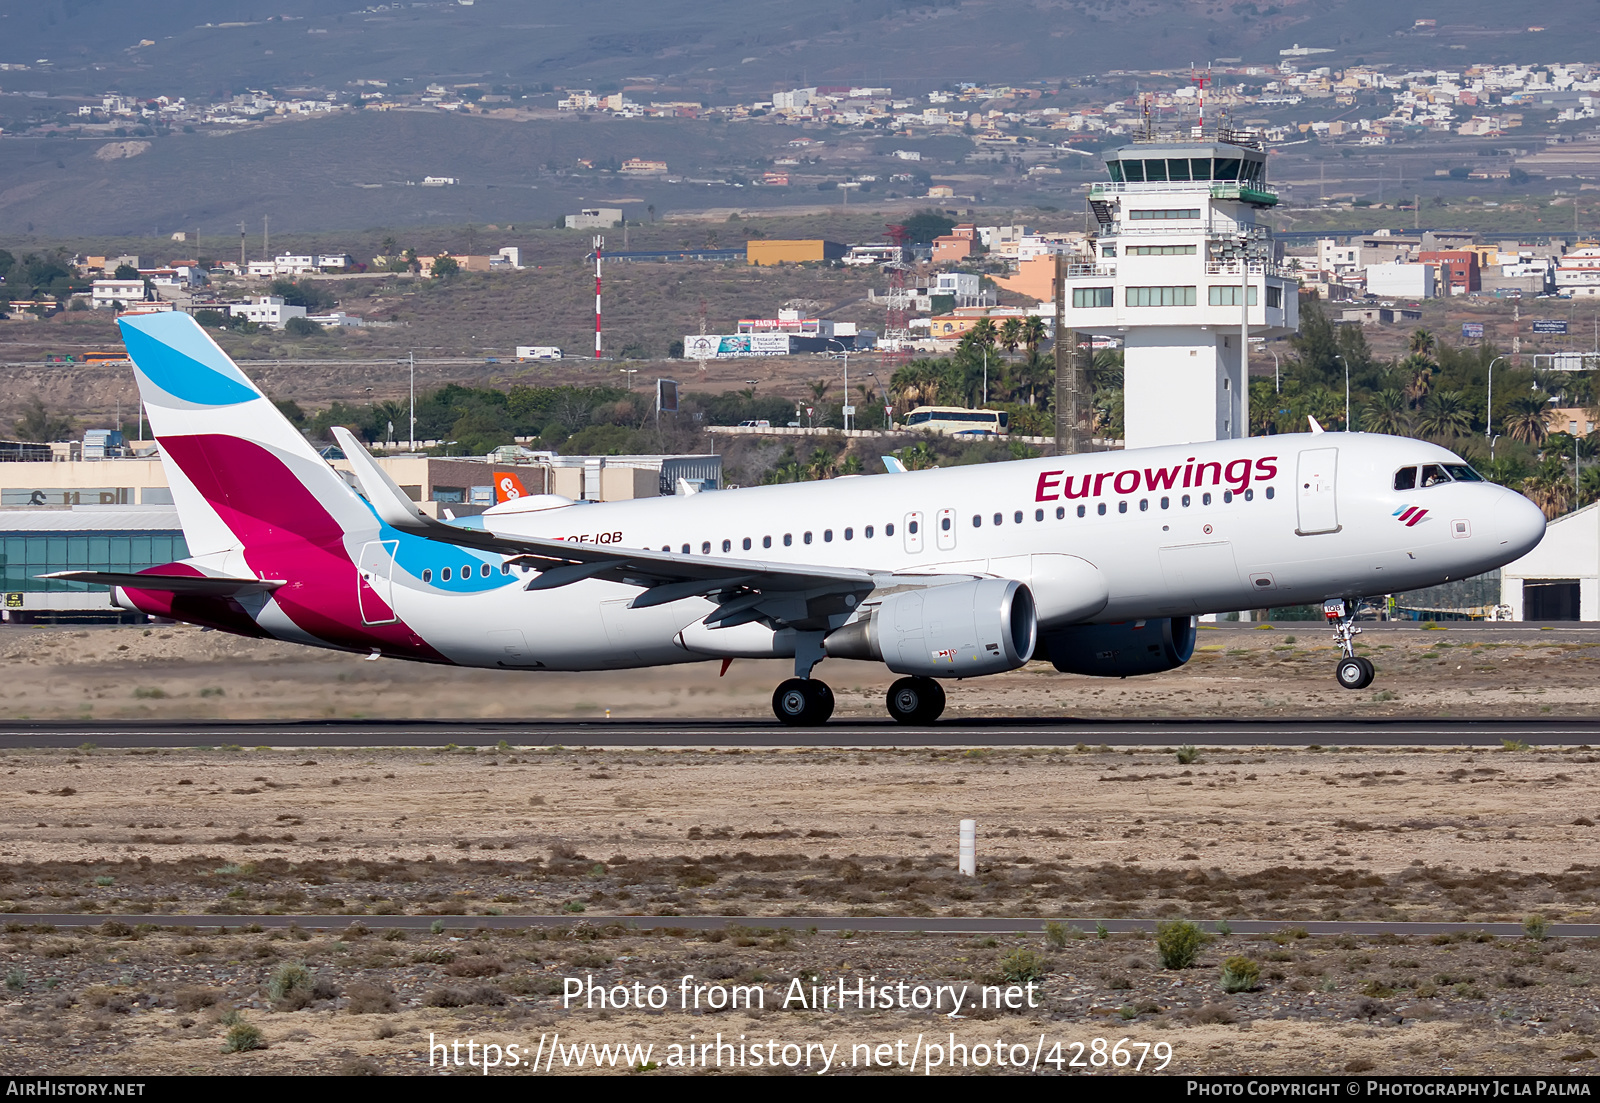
[0, 626, 1600, 1074]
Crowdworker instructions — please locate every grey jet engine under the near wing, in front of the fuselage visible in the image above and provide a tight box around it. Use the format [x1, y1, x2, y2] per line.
[824, 578, 1038, 677]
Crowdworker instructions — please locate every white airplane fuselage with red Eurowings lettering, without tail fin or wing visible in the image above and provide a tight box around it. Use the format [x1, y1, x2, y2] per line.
[368, 434, 1544, 669]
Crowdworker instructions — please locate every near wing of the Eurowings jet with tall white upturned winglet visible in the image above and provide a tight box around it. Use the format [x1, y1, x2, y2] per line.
[333, 426, 915, 628]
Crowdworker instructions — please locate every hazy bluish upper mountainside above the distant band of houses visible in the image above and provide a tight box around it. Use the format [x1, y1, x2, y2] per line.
[0, 0, 1600, 98]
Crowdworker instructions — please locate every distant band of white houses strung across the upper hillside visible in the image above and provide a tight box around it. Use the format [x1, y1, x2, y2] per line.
[9, 54, 1600, 159]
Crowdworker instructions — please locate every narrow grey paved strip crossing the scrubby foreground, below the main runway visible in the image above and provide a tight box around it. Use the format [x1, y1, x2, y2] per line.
[21, 912, 1600, 938]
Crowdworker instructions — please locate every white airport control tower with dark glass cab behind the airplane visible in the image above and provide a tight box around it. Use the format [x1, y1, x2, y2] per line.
[1066, 128, 1299, 448]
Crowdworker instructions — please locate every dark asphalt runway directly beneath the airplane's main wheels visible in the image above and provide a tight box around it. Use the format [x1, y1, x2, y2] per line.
[0, 717, 1600, 752]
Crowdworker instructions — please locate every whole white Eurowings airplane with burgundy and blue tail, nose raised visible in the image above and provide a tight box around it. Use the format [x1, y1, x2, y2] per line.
[53, 312, 1544, 725]
